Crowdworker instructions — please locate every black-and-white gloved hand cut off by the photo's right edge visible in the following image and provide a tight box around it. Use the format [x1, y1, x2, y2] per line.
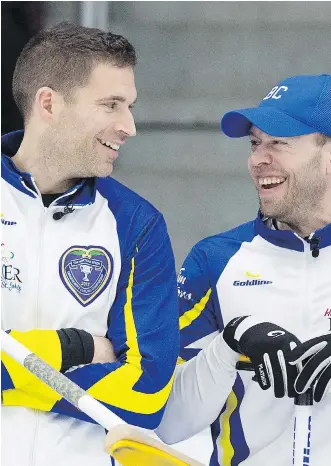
[289, 333, 331, 402]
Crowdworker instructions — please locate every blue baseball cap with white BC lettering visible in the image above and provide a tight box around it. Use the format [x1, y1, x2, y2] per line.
[221, 74, 331, 138]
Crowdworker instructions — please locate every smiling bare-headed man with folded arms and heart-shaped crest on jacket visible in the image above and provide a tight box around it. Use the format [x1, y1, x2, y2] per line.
[1, 20, 179, 466]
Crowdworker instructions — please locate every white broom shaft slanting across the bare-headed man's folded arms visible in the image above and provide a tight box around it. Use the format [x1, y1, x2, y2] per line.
[1, 330, 126, 430]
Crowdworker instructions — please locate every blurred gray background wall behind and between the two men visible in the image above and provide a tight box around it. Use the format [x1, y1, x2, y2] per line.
[3, 1, 331, 269]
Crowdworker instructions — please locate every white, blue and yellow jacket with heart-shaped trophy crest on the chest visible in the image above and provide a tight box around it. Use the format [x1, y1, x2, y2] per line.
[1, 132, 179, 466]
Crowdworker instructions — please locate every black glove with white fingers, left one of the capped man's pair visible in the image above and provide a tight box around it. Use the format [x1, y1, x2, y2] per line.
[223, 316, 300, 398]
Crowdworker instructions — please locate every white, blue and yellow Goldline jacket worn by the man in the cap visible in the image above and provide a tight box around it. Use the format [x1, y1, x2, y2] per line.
[157, 215, 331, 466]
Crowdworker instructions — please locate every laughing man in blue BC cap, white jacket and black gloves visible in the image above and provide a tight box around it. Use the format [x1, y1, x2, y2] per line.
[157, 74, 331, 466]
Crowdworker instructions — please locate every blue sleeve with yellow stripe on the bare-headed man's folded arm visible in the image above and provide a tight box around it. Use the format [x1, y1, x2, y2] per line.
[3, 214, 179, 429]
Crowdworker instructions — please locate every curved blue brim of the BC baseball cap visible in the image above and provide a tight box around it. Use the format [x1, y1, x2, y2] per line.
[221, 107, 318, 138]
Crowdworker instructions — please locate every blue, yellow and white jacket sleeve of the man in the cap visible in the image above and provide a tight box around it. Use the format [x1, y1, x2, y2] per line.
[156, 242, 239, 443]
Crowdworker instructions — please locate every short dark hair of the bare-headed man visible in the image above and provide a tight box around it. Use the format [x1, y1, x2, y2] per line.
[13, 22, 137, 120]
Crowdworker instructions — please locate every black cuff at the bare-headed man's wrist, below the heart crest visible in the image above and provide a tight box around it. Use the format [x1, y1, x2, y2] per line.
[57, 328, 94, 372]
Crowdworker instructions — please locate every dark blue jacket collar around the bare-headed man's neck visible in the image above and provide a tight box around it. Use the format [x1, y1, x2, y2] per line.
[1, 130, 96, 207]
